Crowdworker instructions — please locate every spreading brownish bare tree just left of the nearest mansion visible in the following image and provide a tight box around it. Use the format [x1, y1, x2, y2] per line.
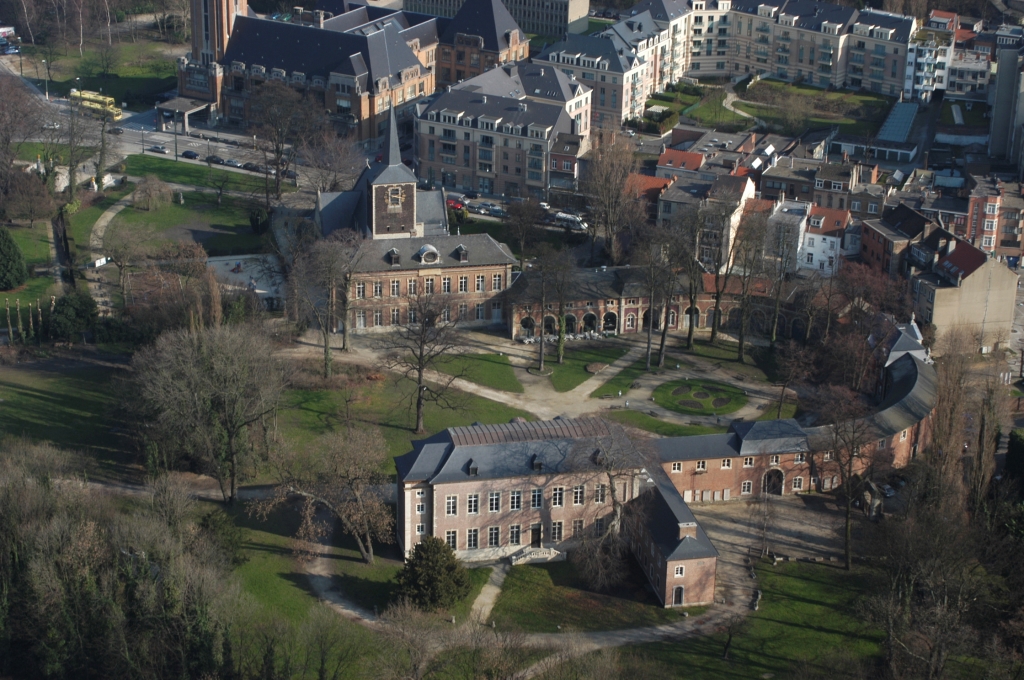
[260, 427, 394, 564]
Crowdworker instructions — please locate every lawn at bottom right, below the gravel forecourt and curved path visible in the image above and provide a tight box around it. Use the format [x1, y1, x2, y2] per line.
[628, 562, 883, 680]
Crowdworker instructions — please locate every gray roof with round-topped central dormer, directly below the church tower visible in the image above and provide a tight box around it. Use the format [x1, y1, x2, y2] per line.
[355, 232, 517, 272]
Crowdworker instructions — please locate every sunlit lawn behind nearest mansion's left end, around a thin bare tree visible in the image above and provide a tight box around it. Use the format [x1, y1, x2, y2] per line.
[278, 372, 532, 473]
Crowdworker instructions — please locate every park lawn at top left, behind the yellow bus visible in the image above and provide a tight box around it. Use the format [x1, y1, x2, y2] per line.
[21, 39, 183, 111]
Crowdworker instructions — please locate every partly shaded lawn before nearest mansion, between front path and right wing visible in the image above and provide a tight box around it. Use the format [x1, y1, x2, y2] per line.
[490, 560, 682, 633]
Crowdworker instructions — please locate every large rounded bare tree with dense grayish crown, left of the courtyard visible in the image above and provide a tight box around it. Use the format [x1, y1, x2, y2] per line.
[126, 325, 284, 503]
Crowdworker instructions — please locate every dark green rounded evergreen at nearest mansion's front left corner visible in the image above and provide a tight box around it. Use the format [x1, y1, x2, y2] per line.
[395, 536, 470, 611]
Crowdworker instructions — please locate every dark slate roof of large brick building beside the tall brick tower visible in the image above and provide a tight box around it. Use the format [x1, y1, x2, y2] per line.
[221, 16, 422, 91]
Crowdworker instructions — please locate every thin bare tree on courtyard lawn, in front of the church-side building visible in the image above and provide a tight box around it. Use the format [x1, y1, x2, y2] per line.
[376, 293, 463, 434]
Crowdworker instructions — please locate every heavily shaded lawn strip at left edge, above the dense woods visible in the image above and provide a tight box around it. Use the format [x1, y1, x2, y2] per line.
[0, 359, 130, 479]
